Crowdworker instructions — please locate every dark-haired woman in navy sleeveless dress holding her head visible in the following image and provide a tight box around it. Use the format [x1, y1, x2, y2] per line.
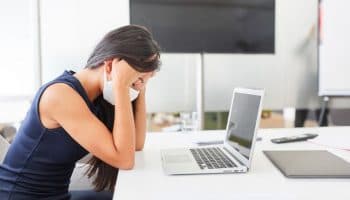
[0, 25, 160, 200]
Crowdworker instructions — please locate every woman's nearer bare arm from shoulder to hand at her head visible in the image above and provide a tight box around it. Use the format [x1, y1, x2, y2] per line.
[39, 61, 138, 169]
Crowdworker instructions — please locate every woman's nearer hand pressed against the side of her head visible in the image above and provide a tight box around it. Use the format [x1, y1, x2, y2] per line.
[111, 58, 141, 87]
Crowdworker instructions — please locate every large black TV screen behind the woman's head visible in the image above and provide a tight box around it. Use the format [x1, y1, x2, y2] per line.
[130, 0, 275, 53]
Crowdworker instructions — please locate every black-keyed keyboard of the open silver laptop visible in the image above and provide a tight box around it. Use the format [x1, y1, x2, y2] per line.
[190, 147, 236, 169]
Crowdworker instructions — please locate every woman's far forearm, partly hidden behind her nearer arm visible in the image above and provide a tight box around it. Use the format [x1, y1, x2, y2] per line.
[133, 88, 147, 151]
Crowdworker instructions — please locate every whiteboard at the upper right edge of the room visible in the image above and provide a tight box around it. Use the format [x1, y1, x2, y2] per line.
[319, 0, 350, 96]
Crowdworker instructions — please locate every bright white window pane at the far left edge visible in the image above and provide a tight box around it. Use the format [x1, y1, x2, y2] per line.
[0, 0, 35, 123]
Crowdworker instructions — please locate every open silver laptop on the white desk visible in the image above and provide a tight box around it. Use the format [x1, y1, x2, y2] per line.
[161, 88, 264, 175]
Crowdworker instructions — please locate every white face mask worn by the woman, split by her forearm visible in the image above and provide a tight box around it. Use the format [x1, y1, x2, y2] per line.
[102, 71, 140, 105]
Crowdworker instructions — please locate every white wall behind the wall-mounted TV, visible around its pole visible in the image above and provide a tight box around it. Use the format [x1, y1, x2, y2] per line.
[41, 0, 318, 112]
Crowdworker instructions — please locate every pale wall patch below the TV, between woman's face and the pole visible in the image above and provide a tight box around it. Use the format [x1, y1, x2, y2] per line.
[147, 54, 197, 112]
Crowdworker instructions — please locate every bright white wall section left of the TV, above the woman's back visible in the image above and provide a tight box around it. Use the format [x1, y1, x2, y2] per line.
[40, 0, 129, 82]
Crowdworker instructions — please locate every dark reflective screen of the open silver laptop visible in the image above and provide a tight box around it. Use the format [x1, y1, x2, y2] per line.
[226, 92, 261, 159]
